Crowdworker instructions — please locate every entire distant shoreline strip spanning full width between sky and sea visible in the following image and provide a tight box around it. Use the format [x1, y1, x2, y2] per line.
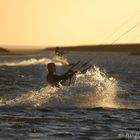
[0, 44, 140, 56]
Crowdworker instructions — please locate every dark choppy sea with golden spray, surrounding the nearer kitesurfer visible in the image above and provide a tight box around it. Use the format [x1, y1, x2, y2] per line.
[0, 53, 140, 140]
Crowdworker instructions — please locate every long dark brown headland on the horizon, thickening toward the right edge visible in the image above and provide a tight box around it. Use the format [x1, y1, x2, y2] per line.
[44, 44, 140, 55]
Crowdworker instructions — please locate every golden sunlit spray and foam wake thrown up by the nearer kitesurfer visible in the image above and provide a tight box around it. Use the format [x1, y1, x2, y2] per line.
[1, 66, 133, 108]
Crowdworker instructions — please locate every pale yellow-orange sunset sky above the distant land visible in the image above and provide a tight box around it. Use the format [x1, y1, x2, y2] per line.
[0, 0, 140, 49]
